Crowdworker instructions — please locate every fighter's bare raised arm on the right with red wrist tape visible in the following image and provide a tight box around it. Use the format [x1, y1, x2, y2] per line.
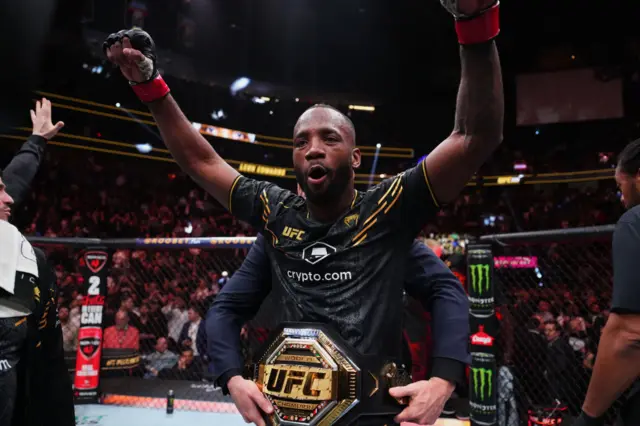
[425, 0, 504, 203]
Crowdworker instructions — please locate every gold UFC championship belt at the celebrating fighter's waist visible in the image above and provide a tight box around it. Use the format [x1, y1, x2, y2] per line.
[248, 323, 411, 426]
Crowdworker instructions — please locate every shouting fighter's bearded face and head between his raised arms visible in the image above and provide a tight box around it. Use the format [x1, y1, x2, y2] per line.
[293, 107, 360, 203]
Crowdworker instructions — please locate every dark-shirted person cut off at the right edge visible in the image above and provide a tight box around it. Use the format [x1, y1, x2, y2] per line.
[574, 139, 640, 426]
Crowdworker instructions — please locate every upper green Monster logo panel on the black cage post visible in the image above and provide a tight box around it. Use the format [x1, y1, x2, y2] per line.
[467, 246, 494, 318]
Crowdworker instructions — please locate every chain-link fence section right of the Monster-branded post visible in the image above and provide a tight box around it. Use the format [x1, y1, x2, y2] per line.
[481, 226, 620, 426]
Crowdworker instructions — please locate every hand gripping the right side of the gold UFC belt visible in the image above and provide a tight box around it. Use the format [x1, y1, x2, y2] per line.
[389, 377, 455, 425]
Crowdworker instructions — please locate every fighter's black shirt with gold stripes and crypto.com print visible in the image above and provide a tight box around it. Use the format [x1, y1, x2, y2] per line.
[229, 162, 438, 358]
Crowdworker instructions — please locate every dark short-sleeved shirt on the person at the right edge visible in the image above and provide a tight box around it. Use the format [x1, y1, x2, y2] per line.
[611, 205, 640, 314]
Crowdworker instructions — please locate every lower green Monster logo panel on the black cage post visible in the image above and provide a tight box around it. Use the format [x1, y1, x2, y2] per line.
[469, 353, 496, 425]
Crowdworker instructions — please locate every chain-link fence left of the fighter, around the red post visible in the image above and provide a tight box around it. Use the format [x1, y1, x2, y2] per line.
[33, 238, 262, 412]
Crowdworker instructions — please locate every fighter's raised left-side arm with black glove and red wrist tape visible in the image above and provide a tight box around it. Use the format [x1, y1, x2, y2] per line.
[104, 29, 239, 208]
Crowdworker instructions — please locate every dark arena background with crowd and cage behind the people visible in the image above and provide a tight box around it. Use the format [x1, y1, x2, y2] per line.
[0, 0, 640, 426]
